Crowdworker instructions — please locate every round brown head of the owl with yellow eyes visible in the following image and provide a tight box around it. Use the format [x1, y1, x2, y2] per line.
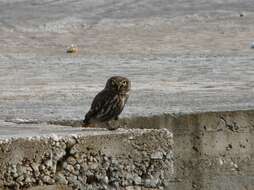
[105, 76, 131, 93]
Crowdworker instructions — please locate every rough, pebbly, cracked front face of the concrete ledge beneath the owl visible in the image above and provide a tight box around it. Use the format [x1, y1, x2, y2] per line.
[0, 126, 174, 189]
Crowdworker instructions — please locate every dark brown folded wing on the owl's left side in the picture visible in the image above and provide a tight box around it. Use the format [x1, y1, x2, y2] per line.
[84, 90, 112, 124]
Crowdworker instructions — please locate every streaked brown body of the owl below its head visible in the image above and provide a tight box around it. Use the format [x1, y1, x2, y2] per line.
[84, 89, 128, 124]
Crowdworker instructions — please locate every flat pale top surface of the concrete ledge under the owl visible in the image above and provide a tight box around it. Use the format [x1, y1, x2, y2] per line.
[0, 121, 142, 142]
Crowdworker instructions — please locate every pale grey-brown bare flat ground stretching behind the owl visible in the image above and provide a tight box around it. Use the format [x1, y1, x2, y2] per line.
[0, 0, 254, 120]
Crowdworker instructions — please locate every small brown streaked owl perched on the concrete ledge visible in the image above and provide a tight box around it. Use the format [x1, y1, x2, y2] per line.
[83, 76, 131, 126]
